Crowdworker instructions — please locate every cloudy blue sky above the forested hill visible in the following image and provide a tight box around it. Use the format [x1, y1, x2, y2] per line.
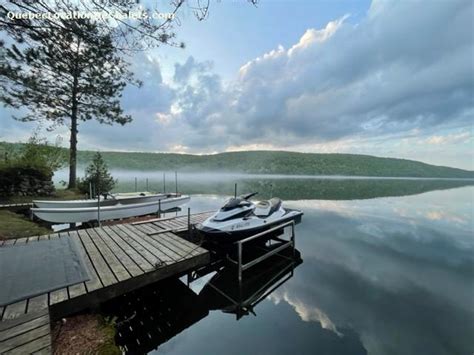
[0, 0, 474, 170]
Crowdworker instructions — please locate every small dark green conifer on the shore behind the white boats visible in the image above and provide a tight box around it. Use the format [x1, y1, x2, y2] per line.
[77, 152, 117, 194]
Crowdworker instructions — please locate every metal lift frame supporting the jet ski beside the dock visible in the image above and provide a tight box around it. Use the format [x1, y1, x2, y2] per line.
[227, 220, 295, 282]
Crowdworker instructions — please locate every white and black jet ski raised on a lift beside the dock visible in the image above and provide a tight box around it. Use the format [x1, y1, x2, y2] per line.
[196, 192, 303, 243]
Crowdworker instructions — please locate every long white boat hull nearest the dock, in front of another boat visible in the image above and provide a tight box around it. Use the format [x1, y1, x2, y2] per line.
[31, 195, 190, 223]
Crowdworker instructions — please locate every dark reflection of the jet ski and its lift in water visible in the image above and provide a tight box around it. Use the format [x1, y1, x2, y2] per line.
[199, 249, 303, 319]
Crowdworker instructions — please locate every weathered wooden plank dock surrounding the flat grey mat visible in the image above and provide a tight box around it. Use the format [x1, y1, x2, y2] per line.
[0, 212, 210, 353]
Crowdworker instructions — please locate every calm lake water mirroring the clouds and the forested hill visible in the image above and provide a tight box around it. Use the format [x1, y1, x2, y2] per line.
[88, 173, 474, 355]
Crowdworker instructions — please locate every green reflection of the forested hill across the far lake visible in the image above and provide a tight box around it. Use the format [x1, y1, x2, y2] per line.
[117, 174, 474, 200]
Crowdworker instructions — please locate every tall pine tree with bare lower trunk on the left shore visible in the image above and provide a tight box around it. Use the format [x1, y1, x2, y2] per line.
[0, 19, 140, 188]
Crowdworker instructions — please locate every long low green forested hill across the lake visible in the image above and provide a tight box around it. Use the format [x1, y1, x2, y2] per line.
[0, 143, 474, 178]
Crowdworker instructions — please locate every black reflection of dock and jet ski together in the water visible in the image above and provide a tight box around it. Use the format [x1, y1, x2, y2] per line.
[102, 249, 314, 354]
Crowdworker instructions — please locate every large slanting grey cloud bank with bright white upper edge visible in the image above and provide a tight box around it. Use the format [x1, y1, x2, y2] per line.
[160, 1, 473, 157]
